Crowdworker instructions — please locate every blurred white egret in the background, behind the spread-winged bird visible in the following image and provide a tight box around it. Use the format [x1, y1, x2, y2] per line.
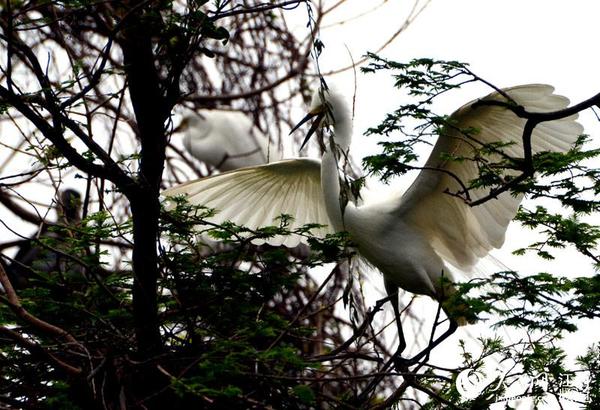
[179, 110, 282, 172]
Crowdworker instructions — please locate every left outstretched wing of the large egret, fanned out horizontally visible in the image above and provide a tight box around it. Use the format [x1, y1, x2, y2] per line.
[162, 158, 333, 247]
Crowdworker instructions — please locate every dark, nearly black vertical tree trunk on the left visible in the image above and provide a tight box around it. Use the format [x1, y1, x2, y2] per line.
[121, 10, 170, 358]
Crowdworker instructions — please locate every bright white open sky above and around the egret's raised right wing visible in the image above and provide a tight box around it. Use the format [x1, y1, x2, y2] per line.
[300, 0, 600, 406]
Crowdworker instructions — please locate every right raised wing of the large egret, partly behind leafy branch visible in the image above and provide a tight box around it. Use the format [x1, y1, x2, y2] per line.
[396, 84, 583, 271]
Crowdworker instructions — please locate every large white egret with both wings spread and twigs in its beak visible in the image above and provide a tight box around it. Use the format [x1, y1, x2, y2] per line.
[164, 84, 582, 360]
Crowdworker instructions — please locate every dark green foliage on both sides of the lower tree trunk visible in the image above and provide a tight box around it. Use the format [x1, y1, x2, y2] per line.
[0, 195, 347, 408]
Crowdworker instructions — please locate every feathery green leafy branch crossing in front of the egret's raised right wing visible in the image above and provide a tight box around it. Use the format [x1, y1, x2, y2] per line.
[363, 55, 600, 207]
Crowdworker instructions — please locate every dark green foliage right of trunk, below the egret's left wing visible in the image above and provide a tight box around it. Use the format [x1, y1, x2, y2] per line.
[152, 198, 346, 408]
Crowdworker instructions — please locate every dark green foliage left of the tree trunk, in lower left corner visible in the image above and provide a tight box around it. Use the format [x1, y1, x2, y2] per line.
[0, 213, 133, 409]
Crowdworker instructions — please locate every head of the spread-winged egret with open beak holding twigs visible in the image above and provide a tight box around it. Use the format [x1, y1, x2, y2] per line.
[290, 88, 352, 150]
